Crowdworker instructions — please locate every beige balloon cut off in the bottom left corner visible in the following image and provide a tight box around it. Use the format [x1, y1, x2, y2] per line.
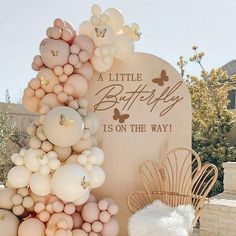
[0, 209, 19, 236]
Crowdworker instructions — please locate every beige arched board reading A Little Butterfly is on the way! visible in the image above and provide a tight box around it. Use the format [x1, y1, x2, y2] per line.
[87, 53, 192, 236]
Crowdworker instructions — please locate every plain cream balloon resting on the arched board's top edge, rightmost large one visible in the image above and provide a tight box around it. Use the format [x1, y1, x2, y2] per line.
[114, 34, 134, 60]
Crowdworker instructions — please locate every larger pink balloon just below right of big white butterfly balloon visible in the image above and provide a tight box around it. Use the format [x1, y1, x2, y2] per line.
[81, 202, 100, 223]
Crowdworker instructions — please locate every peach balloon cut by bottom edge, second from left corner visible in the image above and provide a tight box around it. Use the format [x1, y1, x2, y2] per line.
[18, 218, 46, 236]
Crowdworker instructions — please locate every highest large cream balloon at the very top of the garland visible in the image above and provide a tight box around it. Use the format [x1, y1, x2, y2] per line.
[105, 8, 124, 33]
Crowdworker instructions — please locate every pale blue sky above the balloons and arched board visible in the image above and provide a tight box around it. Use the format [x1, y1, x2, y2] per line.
[0, 0, 236, 102]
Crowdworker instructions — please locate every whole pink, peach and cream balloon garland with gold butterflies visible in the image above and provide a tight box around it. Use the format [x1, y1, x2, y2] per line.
[0, 5, 141, 236]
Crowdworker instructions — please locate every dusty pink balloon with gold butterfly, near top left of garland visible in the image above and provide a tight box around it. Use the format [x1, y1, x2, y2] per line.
[40, 39, 70, 69]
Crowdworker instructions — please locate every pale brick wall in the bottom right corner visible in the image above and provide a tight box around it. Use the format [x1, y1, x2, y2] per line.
[200, 162, 236, 236]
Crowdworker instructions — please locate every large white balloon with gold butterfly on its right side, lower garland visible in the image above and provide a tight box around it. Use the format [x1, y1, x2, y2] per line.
[52, 164, 90, 202]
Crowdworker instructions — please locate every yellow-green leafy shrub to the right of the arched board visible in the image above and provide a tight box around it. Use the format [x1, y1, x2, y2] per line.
[177, 46, 236, 195]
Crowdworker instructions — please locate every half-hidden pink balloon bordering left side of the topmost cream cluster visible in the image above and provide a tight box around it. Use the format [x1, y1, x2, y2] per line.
[73, 35, 95, 58]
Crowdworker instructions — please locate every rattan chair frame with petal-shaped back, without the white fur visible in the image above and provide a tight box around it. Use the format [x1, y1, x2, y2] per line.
[128, 147, 218, 226]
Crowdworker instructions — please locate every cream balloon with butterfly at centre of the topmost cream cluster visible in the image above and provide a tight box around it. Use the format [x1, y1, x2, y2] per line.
[92, 25, 115, 47]
